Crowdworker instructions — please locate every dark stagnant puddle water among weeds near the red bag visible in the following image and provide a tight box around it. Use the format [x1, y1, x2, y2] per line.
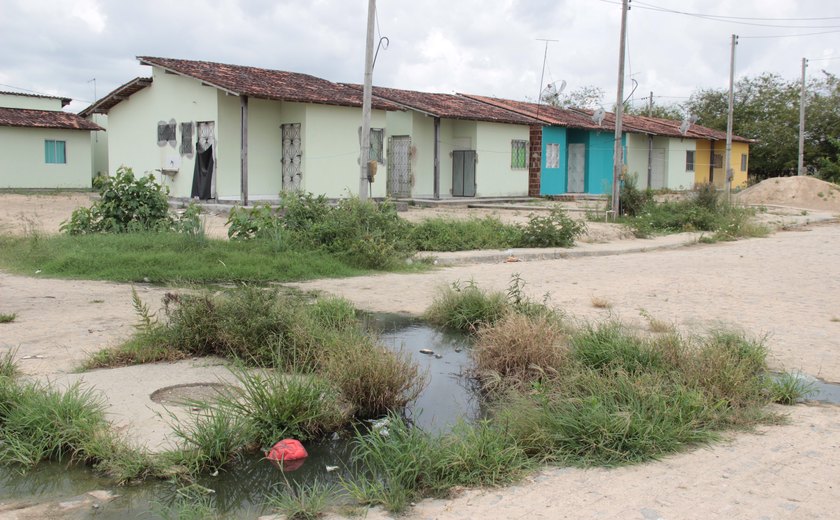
[0, 315, 481, 520]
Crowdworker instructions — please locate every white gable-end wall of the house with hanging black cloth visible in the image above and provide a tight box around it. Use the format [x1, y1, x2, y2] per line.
[108, 68, 220, 197]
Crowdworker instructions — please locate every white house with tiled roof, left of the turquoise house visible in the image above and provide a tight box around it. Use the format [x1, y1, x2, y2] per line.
[360, 87, 536, 198]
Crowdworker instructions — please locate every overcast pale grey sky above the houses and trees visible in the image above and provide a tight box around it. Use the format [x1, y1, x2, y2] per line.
[0, 0, 840, 111]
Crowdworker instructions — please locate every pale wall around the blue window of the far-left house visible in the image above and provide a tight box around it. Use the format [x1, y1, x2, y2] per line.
[0, 127, 91, 188]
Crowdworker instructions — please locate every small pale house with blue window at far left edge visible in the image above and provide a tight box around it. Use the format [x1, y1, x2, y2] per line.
[0, 92, 102, 189]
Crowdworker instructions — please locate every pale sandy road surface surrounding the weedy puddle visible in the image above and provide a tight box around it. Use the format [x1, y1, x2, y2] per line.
[0, 195, 840, 519]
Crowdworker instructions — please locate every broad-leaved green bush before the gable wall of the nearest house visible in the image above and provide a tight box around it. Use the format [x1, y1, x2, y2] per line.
[61, 166, 192, 235]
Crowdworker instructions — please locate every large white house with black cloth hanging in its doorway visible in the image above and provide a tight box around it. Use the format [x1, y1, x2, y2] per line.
[87, 57, 395, 204]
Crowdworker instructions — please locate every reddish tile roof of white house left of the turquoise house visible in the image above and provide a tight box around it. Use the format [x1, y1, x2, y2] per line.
[349, 85, 539, 125]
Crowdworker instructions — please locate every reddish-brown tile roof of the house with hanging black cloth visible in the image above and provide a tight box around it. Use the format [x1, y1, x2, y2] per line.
[137, 56, 398, 110]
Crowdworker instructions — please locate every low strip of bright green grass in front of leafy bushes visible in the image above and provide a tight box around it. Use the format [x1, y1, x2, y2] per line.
[0, 233, 370, 283]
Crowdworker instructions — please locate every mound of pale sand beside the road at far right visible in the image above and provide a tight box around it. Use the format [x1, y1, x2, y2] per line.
[735, 175, 840, 211]
